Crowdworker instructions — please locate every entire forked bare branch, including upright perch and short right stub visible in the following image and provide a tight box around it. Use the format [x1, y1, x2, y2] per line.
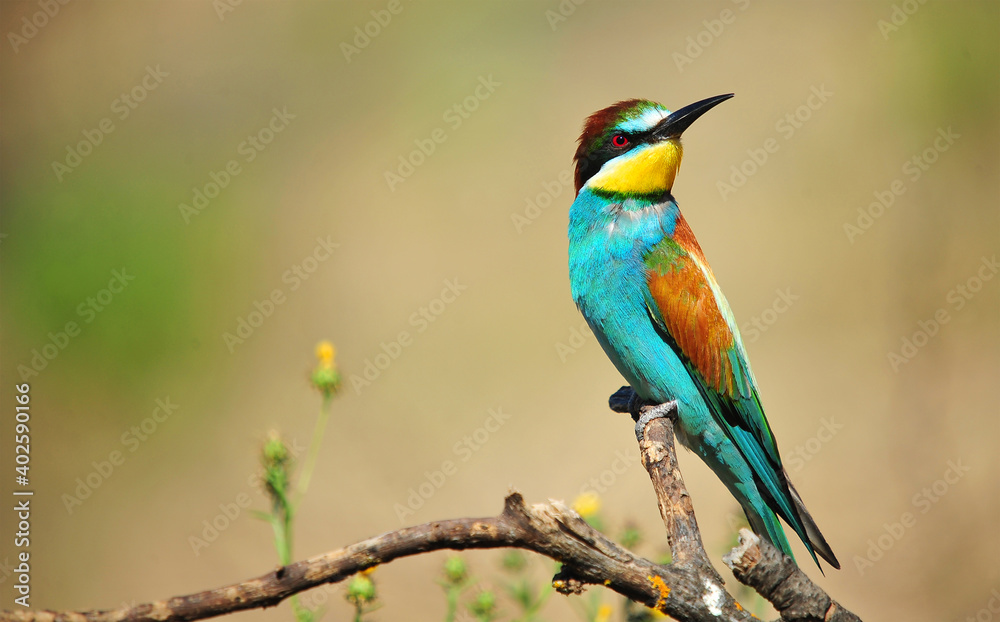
[0, 387, 860, 622]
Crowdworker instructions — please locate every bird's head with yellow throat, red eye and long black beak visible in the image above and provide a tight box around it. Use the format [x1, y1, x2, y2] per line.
[574, 93, 733, 197]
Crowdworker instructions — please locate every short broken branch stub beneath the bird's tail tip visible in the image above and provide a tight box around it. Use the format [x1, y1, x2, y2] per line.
[722, 529, 861, 622]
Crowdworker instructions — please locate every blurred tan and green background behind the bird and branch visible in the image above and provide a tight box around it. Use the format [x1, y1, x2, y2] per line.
[0, 0, 1000, 621]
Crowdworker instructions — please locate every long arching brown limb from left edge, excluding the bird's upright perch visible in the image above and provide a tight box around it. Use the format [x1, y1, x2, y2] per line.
[0, 492, 751, 622]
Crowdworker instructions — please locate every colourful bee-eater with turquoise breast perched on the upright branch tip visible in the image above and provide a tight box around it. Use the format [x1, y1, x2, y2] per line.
[569, 94, 840, 568]
